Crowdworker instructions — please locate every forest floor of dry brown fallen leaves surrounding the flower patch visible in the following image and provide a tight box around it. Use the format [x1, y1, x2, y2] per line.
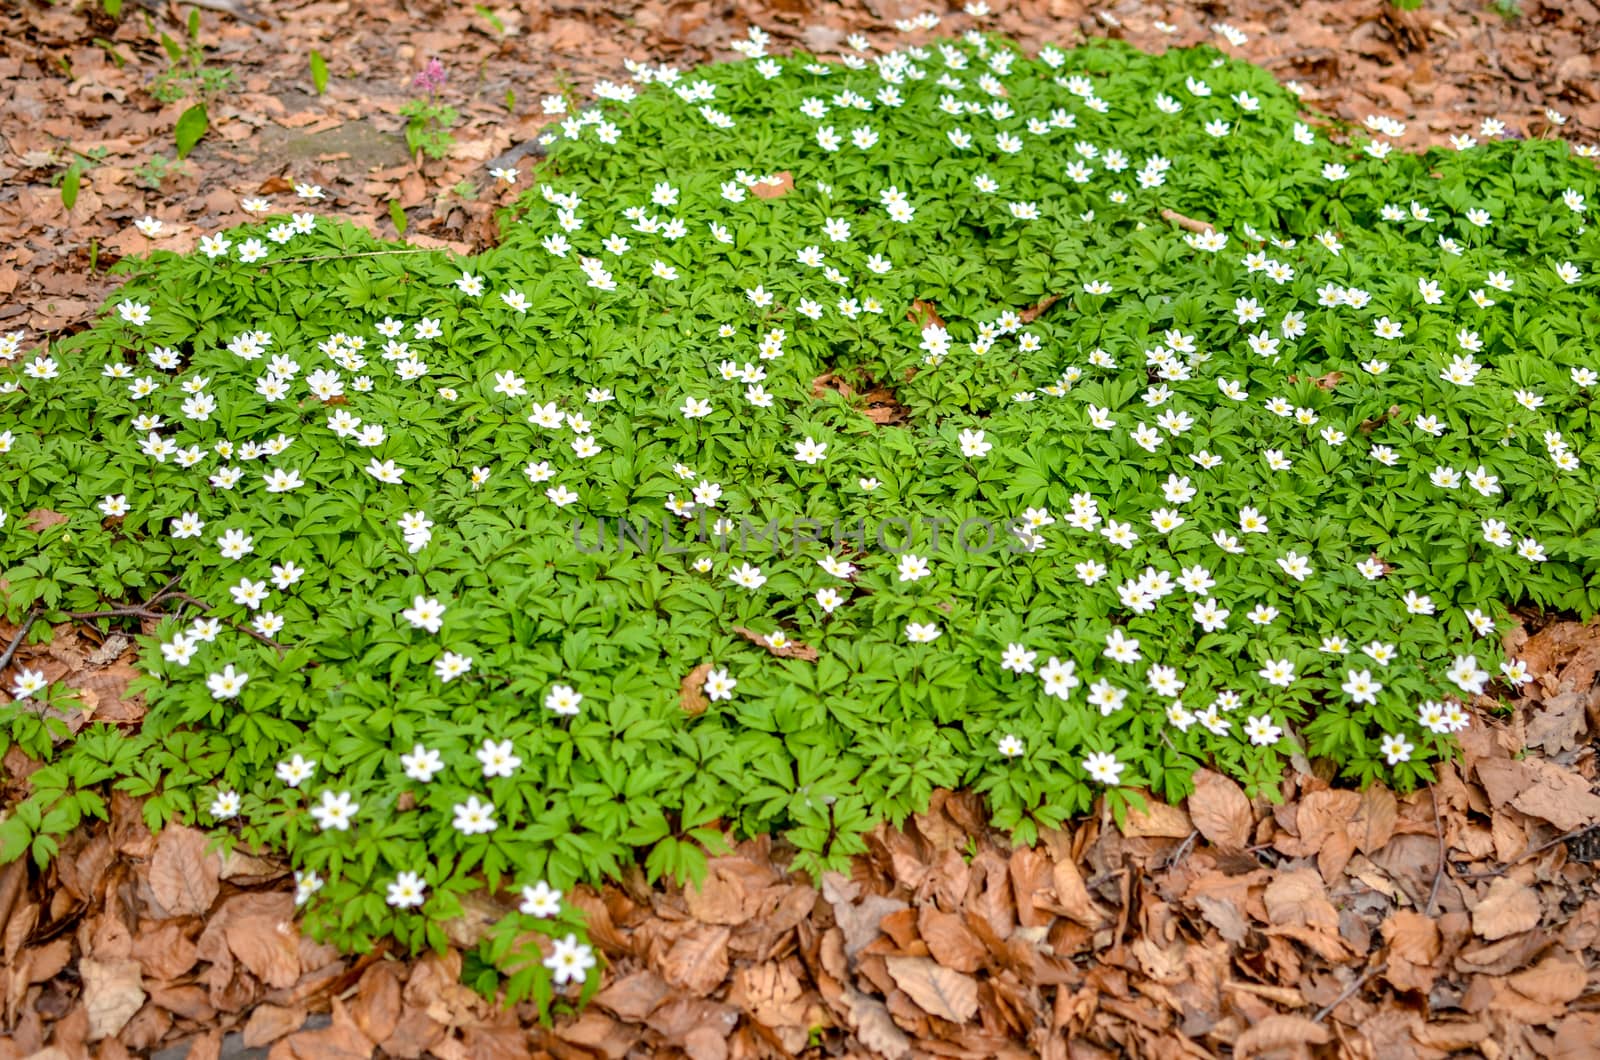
[0, 0, 1600, 1060]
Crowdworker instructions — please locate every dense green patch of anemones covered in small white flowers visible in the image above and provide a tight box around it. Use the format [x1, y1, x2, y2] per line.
[0, 22, 1600, 1001]
